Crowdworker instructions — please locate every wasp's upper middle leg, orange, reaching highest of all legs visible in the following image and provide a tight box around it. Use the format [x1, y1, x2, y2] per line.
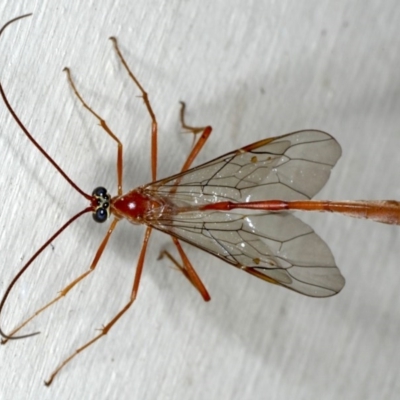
[110, 37, 158, 182]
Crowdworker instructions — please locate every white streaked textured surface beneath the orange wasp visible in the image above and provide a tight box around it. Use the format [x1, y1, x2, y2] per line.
[0, 0, 400, 400]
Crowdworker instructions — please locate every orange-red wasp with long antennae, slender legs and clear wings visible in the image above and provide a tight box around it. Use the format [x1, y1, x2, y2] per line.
[0, 14, 400, 385]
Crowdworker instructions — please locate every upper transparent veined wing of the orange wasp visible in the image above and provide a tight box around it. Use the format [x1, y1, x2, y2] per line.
[145, 130, 341, 205]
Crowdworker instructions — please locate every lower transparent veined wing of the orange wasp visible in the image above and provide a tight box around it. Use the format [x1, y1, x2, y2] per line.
[151, 211, 345, 297]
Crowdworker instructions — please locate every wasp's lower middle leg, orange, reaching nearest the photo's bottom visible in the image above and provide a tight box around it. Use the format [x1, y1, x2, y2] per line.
[45, 226, 152, 386]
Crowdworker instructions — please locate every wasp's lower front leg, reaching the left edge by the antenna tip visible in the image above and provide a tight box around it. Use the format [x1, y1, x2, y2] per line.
[1, 218, 119, 344]
